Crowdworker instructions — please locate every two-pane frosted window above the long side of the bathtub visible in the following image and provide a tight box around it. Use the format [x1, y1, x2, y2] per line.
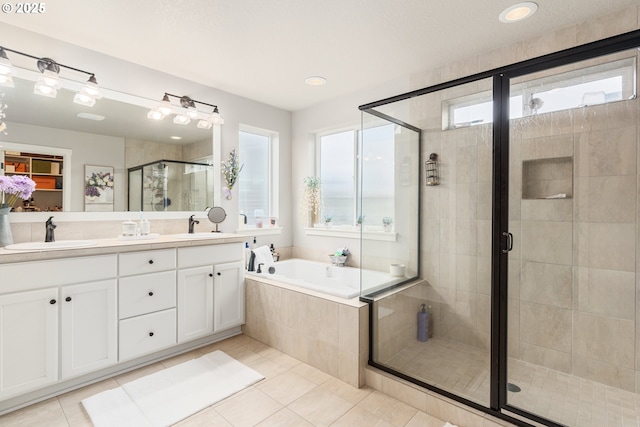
[318, 125, 395, 226]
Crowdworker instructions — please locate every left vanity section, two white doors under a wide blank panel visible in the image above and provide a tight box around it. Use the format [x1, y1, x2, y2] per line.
[0, 255, 117, 398]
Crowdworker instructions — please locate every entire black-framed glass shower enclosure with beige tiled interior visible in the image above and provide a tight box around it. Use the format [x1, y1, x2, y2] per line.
[360, 32, 640, 427]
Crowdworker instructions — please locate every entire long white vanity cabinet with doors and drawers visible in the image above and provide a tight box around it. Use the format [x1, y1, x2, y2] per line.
[0, 237, 244, 413]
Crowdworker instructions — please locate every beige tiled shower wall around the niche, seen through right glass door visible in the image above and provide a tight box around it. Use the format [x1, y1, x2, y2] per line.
[509, 100, 640, 391]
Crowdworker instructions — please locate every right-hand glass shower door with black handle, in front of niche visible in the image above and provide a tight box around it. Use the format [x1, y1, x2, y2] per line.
[506, 49, 640, 427]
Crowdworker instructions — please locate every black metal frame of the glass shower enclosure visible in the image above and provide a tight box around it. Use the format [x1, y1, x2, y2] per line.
[359, 30, 640, 427]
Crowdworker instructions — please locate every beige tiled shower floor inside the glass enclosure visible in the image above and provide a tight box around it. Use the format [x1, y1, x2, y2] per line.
[385, 338, 640, 427]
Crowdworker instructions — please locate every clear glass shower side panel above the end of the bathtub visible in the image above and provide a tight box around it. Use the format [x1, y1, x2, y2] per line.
[357, 113, 420, 296]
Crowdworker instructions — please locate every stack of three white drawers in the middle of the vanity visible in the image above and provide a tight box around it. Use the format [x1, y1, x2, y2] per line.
[118, 249, 176, 361]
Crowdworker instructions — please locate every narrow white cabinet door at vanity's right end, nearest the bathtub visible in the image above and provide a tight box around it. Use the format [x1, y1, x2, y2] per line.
[213, 261, 244, 332]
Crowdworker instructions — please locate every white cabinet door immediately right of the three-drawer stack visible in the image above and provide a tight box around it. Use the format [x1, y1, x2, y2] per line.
[178, 266, 213, 343]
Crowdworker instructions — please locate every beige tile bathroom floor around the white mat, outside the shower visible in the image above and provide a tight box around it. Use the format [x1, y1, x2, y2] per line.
[0, 335, 444, 427]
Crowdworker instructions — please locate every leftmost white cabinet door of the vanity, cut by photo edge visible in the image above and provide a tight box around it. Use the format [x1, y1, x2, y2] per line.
[0, 288, 59, 399]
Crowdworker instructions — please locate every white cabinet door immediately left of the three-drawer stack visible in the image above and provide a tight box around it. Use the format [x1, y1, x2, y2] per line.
[60, 279, 118, 380]
